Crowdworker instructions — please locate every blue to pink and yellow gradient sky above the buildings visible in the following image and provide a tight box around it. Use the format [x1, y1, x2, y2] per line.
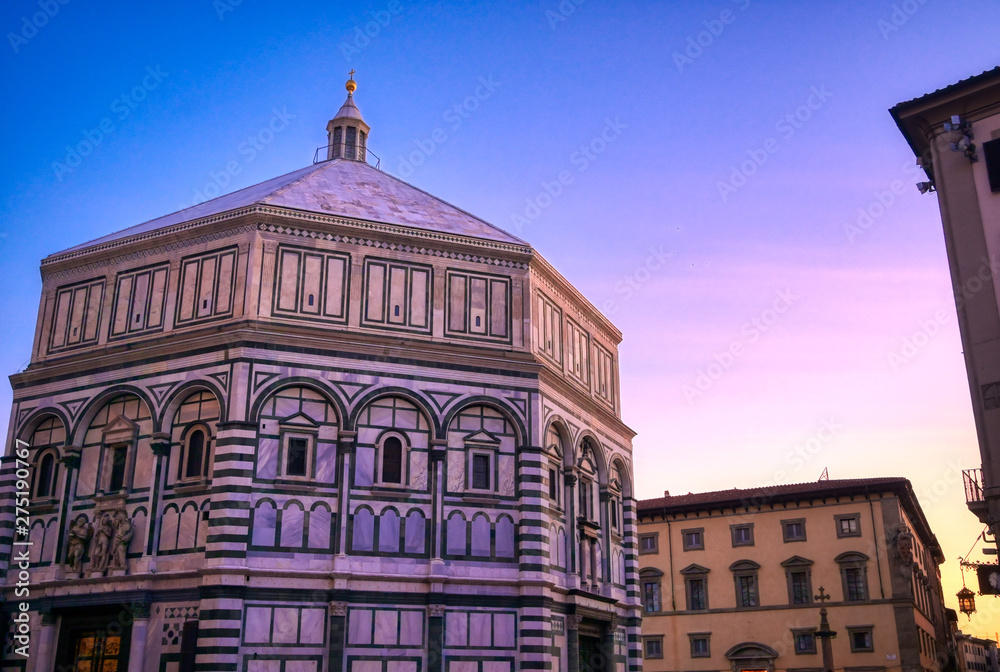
[0, 0, 1000, 636]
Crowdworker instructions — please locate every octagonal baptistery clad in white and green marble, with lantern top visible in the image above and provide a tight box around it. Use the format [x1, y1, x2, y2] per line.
[0, 81, 641, 672]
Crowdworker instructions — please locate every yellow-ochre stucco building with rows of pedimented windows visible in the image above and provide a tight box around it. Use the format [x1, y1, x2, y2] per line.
[638, 478, 954, 672]
